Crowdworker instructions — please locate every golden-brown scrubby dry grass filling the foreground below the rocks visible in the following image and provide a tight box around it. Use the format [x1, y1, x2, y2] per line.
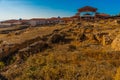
[4, 50, 120, 80]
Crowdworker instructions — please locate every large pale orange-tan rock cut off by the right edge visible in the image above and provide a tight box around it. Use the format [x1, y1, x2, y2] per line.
[111, 35, 120, 51]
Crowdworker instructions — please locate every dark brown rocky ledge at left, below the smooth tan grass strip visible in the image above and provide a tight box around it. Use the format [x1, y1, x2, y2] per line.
[0, 37, 48, 60]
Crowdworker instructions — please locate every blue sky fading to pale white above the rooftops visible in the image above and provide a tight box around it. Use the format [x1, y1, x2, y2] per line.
[0, 0, 120, 20]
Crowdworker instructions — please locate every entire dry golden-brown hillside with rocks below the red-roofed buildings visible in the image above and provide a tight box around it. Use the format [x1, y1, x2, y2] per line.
[0, 19, 120, 80]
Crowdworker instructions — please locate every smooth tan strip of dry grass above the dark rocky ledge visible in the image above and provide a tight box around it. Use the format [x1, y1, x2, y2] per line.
[0, 26, 62, 44]
